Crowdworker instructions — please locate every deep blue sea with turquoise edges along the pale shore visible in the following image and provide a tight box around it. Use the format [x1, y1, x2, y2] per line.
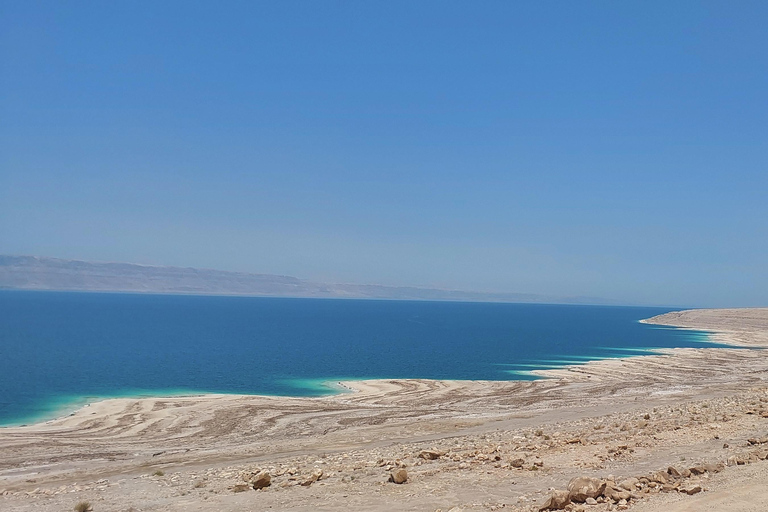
[0, 291, 720, 425]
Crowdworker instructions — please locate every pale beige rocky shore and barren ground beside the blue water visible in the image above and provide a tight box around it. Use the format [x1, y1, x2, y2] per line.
[0, 308, 768, 512]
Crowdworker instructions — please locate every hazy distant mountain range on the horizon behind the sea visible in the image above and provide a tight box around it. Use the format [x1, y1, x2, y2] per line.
[0, 255, 613, 304]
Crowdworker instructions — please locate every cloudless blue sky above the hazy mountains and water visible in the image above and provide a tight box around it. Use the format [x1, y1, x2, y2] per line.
[0, 0, 768, 306]
